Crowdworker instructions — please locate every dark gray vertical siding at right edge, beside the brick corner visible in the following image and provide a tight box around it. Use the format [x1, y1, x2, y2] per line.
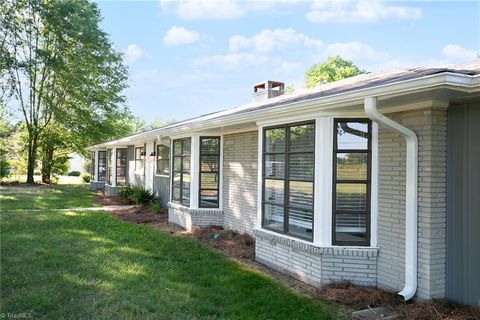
[447, 102, 480, 307]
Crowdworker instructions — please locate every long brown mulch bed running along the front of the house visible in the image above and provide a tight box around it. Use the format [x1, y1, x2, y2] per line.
[103, 197, 480, 320]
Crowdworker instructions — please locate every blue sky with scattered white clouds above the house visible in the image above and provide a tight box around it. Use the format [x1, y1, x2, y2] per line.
[98, 0, 480, 122]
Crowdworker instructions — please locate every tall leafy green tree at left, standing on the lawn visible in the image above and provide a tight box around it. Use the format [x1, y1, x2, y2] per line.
[0, 0, 129, 183]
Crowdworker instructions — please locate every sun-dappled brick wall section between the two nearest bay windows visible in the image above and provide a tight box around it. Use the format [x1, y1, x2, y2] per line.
[223, 131, 258, 234]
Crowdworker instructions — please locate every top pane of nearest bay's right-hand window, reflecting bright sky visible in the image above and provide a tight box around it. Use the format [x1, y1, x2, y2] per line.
[337, 122, 368, 150]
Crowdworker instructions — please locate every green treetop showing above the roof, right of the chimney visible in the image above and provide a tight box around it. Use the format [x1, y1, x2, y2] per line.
[305, 56, 366, 88]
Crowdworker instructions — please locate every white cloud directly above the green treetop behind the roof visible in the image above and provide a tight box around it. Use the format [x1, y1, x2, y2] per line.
[321, 41, 388, 61]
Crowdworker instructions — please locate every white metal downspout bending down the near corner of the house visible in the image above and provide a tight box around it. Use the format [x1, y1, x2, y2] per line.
[364, 97, 418, 301]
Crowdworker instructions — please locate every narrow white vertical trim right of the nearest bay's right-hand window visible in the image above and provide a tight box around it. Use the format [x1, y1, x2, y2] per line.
[370, 121, 378, 247]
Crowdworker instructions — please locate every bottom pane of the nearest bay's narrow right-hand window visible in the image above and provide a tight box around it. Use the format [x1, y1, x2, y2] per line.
[335, 214, 367, 242]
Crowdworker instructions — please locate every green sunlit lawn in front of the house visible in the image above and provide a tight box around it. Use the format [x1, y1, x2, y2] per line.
[0, 186, 334, 319]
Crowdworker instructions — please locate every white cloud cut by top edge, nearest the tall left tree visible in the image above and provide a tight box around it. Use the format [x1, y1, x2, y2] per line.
[160, 0, 245, 20]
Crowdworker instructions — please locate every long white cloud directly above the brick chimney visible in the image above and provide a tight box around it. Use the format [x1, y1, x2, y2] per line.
[229, 28, 322, 53]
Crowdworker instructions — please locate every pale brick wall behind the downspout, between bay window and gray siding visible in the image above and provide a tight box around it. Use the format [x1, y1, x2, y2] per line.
[377, 107, 447, 298]
